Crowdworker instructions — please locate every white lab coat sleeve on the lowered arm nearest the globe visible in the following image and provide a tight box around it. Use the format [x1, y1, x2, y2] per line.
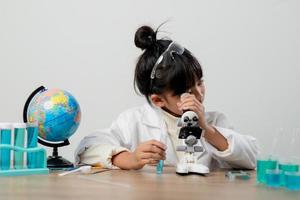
[75, 113, 131, 168]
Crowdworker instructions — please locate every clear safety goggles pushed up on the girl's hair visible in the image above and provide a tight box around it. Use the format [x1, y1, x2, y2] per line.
[150, 41, 184, 81]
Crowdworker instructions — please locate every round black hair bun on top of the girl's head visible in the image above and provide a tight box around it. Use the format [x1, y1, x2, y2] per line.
[134, 26, 156, 50]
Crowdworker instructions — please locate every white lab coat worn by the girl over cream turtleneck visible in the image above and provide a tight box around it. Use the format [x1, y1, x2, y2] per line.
[75, 104, 258, 170]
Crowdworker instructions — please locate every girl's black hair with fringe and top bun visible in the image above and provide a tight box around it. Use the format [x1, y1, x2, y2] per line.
[134, 26, 203, 103]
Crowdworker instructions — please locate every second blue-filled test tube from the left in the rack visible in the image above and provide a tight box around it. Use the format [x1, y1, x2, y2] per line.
[13, 123, 26, 169]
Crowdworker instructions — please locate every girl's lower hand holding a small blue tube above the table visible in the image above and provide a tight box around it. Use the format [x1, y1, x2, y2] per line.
[132, 140, 166, 169]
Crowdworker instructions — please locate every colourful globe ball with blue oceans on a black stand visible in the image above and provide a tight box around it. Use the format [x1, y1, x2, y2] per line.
[27, 89, 81, 142]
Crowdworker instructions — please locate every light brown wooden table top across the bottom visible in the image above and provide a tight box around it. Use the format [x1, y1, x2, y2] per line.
[0, 167, 300, 200]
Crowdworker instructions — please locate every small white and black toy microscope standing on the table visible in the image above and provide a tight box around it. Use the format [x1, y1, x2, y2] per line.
[176, 111, 209, 175]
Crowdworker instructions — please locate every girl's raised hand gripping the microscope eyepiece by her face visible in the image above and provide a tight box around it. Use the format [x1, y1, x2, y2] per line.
[177, 93, 208, 130]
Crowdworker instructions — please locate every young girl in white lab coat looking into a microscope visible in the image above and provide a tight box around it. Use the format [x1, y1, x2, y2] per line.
[75, 26, 257, 170]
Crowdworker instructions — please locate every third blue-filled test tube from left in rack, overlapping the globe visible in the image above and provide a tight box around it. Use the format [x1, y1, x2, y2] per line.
[27, 122, 38, 168]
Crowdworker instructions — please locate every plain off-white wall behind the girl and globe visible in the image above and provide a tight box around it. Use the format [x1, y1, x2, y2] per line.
[0, 0, 300, 161]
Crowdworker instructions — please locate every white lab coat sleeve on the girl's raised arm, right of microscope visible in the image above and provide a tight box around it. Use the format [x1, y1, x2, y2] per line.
[206, 114, 258, 169]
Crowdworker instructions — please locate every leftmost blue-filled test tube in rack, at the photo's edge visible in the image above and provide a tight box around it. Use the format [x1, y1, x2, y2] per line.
[0, 123, 11, 170]
